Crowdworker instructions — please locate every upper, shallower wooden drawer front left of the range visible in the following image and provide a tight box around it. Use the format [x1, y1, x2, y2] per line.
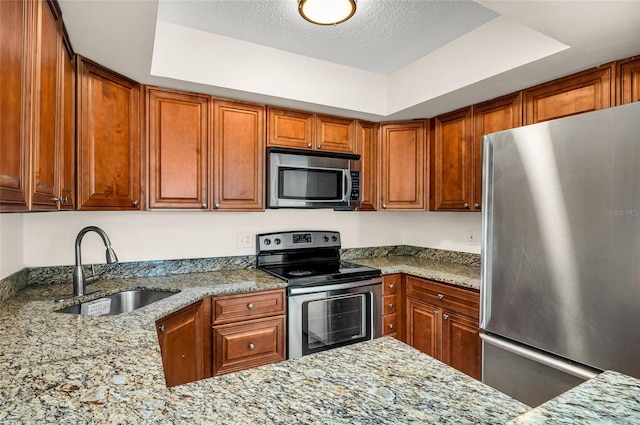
[213, 289, 285, 325]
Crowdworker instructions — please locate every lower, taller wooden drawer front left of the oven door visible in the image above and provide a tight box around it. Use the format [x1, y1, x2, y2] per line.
[213, 317, 285, 375]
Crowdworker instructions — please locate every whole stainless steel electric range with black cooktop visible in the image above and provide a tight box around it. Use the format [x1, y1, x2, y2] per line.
[256, 230, 382, 358]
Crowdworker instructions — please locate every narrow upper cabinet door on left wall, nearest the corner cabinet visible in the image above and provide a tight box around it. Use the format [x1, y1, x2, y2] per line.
[58, 30, 76, 210]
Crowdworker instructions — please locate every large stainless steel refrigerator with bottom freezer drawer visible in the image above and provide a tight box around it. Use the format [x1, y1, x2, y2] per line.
[480, 102, 640, 406]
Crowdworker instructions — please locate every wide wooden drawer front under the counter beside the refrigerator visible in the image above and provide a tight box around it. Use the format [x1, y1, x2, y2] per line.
[407, 276, 480, 318]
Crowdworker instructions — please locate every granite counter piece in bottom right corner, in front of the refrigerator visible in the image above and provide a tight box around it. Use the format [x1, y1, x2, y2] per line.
[511, 371, 640, 425]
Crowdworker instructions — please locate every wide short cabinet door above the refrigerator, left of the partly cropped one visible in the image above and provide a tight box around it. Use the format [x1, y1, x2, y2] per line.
[523, 66, 614, 125]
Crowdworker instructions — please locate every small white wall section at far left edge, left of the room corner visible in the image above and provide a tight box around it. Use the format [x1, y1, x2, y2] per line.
[0, 213, 25, 279]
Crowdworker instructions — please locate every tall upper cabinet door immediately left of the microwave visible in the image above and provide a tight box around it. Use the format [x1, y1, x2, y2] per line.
[213, 99, 265, 211]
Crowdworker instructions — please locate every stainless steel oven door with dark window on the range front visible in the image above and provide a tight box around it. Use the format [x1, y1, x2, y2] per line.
[287, 278, 382, 358]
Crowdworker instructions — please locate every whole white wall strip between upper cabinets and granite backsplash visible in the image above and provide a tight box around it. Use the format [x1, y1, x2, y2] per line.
[0, 210, 480, 278]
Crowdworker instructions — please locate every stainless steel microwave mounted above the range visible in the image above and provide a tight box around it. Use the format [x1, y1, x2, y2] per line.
[267, 148, 360, 210]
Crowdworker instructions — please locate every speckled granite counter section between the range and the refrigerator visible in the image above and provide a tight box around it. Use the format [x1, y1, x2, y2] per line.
[350, 256, 480, 290]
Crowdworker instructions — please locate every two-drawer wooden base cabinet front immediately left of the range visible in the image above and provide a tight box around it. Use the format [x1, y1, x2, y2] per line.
[211, 289, 286, 375]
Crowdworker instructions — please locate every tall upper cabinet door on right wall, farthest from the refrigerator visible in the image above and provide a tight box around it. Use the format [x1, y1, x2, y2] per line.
[430, 108, 473, 211]
